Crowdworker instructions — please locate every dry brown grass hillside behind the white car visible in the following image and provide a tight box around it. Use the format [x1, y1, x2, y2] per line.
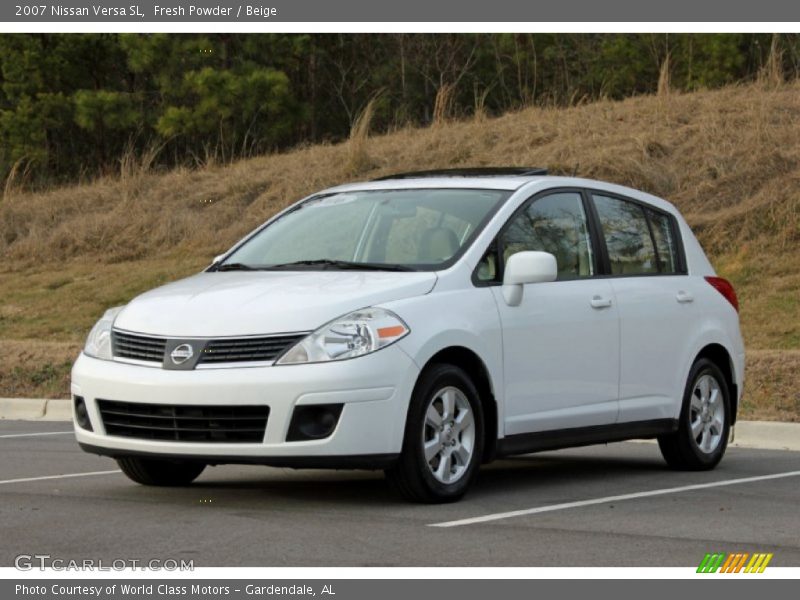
[0, 82, 800, 420]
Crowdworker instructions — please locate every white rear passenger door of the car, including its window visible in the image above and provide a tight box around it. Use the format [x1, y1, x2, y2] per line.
[592, 192, 697, 423]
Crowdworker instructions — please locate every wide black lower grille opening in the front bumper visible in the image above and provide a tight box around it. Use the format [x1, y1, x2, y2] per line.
[97, 400, 269, 443]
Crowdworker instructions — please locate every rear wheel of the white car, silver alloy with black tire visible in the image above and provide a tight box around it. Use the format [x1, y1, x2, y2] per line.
[658, 358, 732, 471]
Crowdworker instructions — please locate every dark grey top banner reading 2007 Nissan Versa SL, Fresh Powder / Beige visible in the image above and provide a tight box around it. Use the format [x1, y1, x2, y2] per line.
[0, 0, 800, 23]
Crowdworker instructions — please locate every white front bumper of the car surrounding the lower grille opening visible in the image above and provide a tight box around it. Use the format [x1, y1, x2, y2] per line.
[72, 345, 419, 467]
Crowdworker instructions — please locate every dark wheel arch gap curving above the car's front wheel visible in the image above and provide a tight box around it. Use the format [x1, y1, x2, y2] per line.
[420, 346, 498, 463]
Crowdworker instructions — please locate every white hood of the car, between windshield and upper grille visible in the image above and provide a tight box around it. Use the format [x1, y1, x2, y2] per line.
[114, 271, 436, 337]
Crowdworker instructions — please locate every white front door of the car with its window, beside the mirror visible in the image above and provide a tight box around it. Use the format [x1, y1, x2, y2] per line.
[476, 190, 619, 435]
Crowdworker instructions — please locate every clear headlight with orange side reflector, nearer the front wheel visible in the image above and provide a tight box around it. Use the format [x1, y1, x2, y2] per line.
[276, 308, 410, 365]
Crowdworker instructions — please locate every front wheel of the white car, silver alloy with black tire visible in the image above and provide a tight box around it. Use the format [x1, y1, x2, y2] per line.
[386, 364, 484, 503]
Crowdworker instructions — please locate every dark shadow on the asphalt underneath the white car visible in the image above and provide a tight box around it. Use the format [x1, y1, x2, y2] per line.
[92, 446, 692, 509]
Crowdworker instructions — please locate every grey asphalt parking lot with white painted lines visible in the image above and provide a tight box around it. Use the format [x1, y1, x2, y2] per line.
[0, 421, 800, 567]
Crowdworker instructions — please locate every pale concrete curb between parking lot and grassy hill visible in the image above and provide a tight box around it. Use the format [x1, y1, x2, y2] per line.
[0, 398, 800, 452]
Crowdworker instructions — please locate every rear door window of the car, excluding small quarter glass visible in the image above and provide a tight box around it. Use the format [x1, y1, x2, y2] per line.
[594, 195, 659, 275]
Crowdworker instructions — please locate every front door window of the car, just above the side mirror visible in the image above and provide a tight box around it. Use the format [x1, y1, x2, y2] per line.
[496, 192, 594, 279]
